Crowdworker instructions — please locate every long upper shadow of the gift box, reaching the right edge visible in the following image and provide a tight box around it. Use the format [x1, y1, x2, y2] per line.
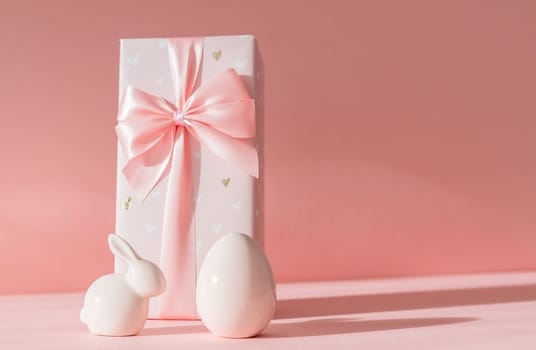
[274, 285, 536, 319]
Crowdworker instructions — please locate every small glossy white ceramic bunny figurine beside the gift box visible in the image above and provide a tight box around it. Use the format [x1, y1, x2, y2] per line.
[80, 234, 166, 336]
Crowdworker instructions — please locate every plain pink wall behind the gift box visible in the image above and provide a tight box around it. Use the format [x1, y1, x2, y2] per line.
[0, 0, 536, 293]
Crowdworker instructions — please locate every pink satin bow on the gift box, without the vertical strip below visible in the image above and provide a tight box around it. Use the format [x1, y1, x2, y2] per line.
[116, 45, 258, 199]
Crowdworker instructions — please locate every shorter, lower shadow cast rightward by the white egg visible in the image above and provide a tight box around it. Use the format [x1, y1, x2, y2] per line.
[261, 317, 478, 338]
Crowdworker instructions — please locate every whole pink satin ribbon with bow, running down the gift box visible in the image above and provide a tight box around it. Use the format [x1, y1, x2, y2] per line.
[116, 38, 258, 318]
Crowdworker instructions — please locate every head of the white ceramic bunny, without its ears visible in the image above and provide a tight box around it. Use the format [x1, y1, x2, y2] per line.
[126, 259, 166, 298]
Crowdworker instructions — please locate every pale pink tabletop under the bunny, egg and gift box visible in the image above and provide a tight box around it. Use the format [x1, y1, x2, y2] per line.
[0, 272, 536, 350]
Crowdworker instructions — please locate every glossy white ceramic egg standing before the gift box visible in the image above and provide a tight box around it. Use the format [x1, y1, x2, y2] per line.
[196, 233, 276, 338]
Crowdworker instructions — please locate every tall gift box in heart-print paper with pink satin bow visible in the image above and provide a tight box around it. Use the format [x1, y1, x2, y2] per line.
[115, 35, 263, 319]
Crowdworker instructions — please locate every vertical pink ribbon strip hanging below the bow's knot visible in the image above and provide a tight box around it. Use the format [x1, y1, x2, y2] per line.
[159, 128, 196, 319]
